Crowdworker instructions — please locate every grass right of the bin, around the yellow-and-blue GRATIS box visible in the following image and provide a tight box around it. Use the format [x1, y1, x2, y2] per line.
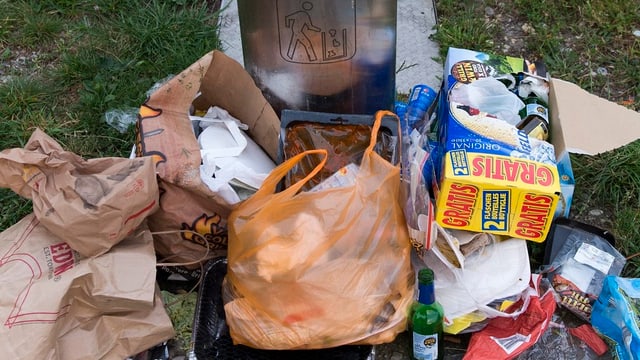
[434, 0, 640, 277]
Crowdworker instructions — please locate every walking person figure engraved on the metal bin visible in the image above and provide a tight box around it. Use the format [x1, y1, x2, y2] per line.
[284, 1, 322, 61]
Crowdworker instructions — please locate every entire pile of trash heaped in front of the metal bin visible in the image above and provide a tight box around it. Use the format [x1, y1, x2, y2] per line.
[0, 48, 640, 359]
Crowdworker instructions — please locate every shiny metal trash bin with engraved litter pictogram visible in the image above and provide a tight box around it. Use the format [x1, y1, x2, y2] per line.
[238, 0, 397, 115]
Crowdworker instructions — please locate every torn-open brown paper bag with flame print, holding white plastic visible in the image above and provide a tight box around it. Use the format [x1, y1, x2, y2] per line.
[136, 51, 280, 262]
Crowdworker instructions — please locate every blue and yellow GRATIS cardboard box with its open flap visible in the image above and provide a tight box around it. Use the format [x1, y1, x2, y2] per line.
[434, 48, 640, 242]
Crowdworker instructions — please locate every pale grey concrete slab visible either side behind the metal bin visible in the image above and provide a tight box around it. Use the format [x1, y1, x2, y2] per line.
[220, 0, 442, 94]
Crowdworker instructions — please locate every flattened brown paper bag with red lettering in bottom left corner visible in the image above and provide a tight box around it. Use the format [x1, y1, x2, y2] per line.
[0, 214, 174, 360]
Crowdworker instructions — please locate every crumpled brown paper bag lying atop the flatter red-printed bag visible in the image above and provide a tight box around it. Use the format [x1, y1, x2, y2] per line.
[0, 129, 158, 257]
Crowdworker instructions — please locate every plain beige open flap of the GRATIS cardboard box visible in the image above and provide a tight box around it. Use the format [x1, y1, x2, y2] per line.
[551, 78, 640, 155]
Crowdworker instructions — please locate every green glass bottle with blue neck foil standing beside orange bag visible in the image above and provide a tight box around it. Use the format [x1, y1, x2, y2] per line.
[411, 268, 444, 360]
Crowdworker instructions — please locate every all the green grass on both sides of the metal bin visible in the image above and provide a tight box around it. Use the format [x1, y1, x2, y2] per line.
[0, 0, 640, 277]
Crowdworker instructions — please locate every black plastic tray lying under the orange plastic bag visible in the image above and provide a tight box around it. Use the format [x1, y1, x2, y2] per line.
[192, 257, 373, 360]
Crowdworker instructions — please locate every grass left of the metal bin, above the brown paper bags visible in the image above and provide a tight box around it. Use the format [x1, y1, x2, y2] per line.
[0, 0, 221, 230]
